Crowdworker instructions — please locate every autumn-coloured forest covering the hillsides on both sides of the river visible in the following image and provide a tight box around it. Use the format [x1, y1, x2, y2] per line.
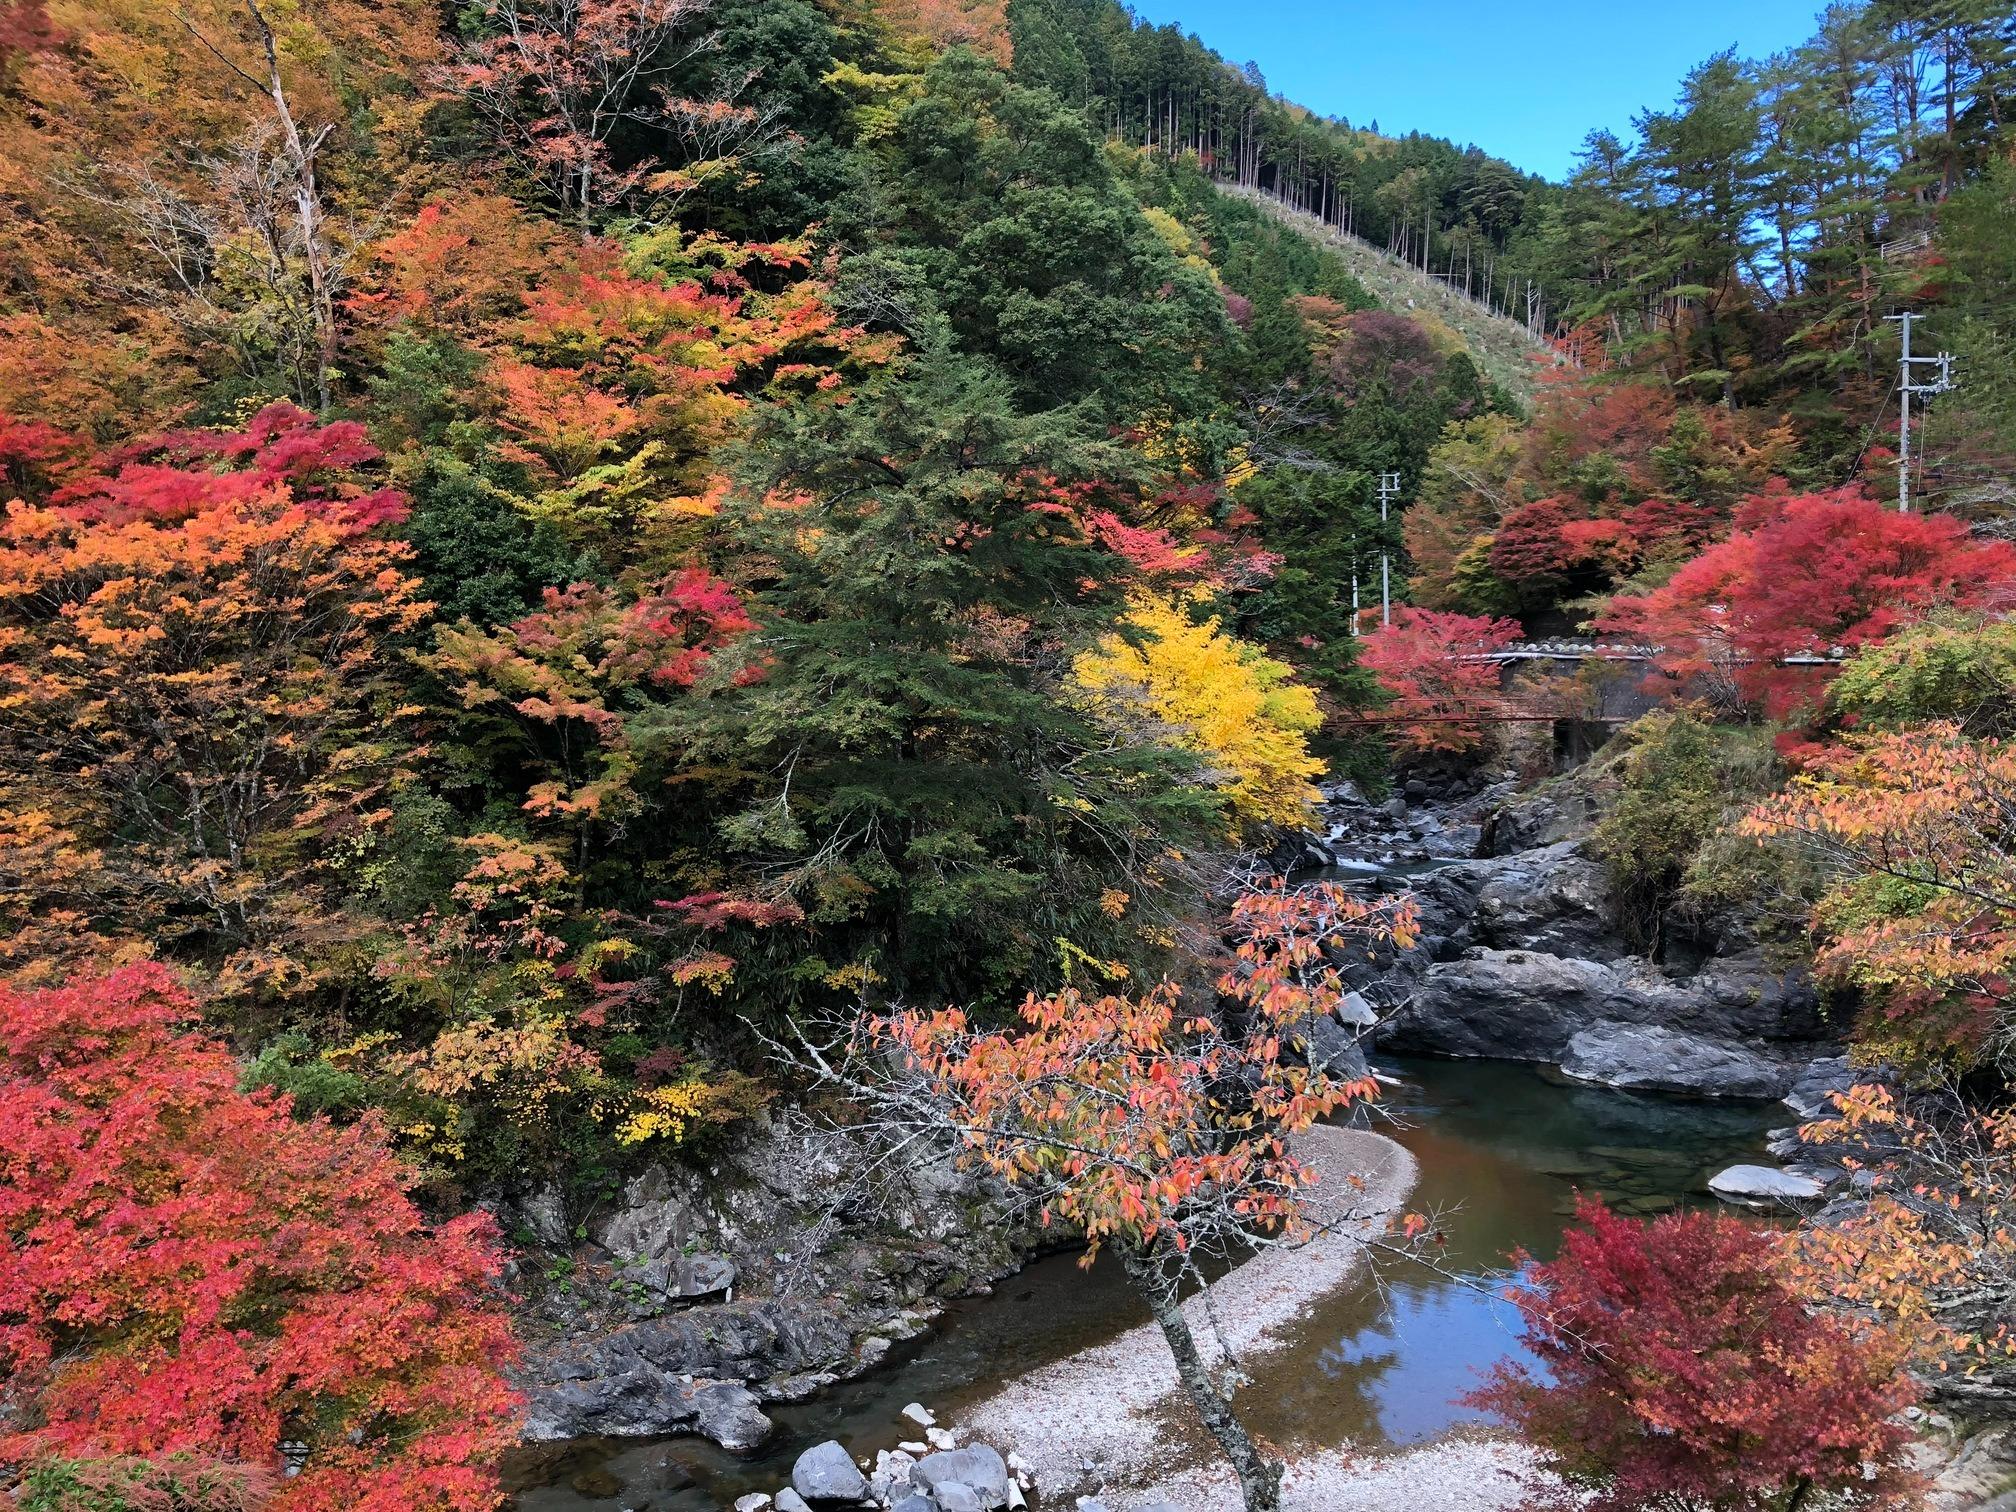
[0, 0, 2016, 1512]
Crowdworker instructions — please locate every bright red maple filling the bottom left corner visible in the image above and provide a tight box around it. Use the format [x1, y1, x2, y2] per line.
[0, 966, 514, 1512]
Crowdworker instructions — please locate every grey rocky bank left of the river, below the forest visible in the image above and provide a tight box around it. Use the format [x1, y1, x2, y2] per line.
[502, 1119, 1034, 1450]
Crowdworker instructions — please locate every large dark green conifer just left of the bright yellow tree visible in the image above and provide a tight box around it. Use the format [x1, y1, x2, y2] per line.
[704, 347, 1216, 1008]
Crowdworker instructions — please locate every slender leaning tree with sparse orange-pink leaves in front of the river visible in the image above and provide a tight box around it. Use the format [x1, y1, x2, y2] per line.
[814, 881, 1415, 1512]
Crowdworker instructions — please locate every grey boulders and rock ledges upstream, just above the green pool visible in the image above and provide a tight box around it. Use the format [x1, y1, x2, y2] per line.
[1325, 780, 1833, 1097]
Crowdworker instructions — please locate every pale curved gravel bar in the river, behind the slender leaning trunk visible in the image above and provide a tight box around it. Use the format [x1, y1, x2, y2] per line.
[962, 1127, 1419, 1512]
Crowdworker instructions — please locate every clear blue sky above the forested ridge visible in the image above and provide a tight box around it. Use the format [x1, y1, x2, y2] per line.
[1133, 0, 1820, 177]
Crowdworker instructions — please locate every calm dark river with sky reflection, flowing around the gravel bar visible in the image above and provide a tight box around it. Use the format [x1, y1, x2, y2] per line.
[516, 1058, 1792, 1512]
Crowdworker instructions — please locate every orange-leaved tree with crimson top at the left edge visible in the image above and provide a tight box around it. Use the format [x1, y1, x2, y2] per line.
[0, 405, 425, 988]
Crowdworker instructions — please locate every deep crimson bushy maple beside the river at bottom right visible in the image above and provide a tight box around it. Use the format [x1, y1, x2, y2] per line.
[1472, 1200, 1915, 1512]
